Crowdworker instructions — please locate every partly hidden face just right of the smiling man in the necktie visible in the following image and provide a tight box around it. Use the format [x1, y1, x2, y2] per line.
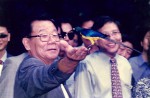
[117, 41, 133, 59]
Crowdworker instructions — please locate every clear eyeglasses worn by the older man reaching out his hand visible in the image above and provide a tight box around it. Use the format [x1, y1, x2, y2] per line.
[27, 34, 60, 42]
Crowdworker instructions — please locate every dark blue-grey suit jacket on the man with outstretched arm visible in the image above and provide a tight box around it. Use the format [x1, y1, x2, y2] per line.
[14, 56, 71, 98]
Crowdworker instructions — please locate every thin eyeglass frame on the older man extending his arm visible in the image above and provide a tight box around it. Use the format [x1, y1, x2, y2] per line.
[26, 34, 60, 42]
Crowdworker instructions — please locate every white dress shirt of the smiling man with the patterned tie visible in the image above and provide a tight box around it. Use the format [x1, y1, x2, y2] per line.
[72, 52, 132, 98]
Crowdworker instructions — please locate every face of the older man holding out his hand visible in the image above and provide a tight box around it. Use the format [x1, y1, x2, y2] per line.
[26, 20, 59, 61]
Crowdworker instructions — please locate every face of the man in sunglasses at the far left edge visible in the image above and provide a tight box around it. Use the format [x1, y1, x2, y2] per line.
[0, 26, 10, 51]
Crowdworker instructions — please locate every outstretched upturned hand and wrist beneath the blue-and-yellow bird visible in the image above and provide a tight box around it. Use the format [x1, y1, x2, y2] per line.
[58, 40, 88, 73]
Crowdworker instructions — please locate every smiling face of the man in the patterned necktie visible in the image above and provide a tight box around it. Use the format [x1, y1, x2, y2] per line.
[97, 22, 122, 56]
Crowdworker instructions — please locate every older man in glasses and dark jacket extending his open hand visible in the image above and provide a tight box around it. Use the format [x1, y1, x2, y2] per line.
[0, 14, 87, 98]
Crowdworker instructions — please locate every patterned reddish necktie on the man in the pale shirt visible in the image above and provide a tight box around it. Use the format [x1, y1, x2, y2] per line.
[110, 58, 123, 98]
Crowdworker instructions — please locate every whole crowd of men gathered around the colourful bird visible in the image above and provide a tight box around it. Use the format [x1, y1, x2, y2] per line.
[0, 11, 150, 98]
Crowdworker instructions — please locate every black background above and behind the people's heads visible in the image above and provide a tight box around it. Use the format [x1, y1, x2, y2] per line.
[0, 0, 150, 55]
